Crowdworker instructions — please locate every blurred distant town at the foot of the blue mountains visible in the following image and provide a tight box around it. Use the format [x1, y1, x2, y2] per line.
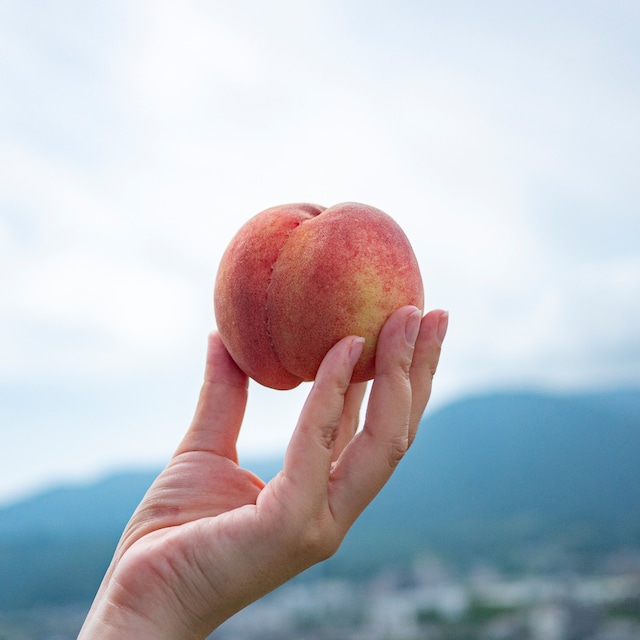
[0, 548, 640, 640]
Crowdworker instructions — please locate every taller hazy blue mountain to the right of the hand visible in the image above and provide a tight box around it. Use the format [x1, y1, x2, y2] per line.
[340, 391, 640, 564]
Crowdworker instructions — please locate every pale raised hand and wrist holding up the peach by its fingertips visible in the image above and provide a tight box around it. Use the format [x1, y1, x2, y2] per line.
[79, 307, 448, 640]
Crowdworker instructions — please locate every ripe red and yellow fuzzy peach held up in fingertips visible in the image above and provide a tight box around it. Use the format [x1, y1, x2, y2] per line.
[214, 202, 424, 389]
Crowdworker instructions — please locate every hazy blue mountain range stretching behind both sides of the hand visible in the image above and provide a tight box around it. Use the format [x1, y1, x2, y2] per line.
[0, 390, 640, 611]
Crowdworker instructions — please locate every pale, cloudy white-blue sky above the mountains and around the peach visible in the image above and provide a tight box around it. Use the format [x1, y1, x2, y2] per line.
[0, 0, 640, 504]
